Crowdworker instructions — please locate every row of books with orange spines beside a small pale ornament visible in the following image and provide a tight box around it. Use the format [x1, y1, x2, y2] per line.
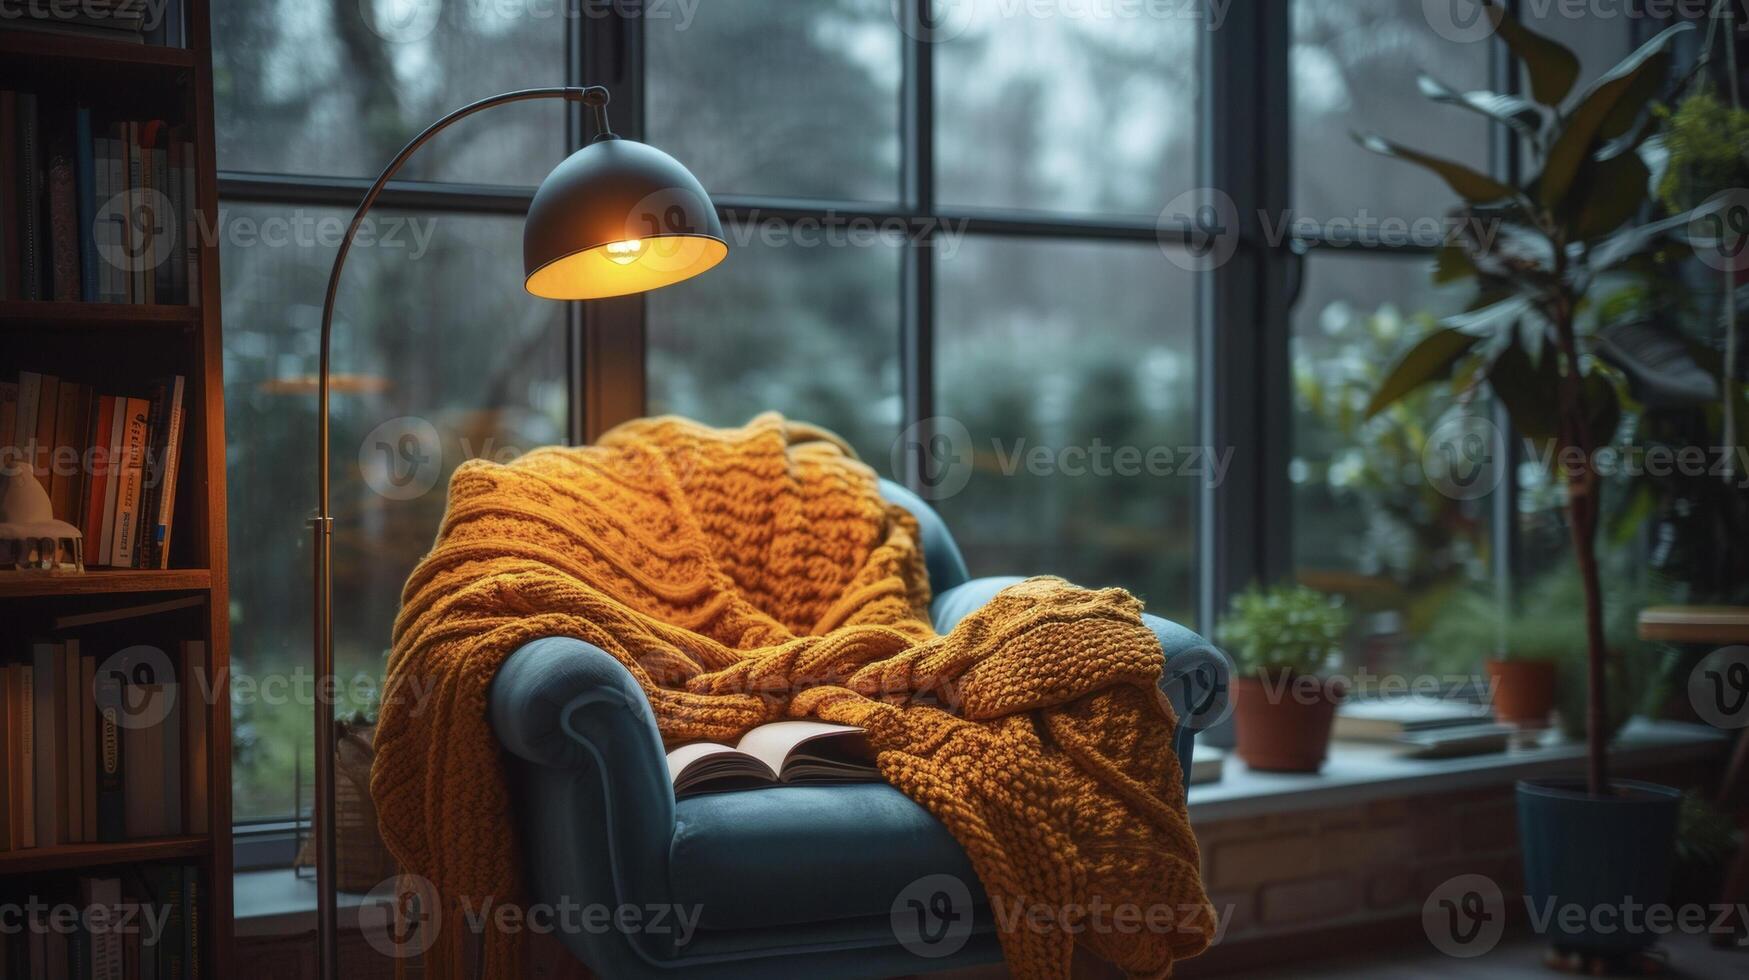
[0, 371, 185, 569]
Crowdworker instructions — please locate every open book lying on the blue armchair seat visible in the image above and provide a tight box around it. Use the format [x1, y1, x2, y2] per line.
[668, 721, 880, 796]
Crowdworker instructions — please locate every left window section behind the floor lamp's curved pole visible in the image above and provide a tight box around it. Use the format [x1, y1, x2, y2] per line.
[213, 0, 572, 823]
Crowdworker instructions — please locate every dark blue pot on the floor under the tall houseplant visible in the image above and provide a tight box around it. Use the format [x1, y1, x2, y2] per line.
[1518, 779, 1683, 954]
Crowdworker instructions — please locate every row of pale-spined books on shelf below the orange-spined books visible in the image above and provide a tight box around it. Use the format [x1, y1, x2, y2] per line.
[0, 597, 206, 851]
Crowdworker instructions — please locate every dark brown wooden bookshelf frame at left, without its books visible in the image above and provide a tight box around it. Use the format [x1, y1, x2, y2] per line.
[0, 0, 233, 977]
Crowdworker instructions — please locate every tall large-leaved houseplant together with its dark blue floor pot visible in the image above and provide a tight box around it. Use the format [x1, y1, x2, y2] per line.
[1359, 4, 1700, 964]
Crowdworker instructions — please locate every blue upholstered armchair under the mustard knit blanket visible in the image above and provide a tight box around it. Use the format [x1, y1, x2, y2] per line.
[490, 481, 1230, 980]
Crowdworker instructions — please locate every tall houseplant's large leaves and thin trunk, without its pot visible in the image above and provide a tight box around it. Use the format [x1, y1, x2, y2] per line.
[1357, 4, 1697, 796]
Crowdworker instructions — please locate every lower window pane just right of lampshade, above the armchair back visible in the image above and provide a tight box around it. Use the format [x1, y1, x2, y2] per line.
[647, 226, 902, 462]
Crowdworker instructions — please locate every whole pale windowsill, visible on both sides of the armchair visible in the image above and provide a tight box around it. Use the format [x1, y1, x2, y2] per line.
[234, 719, 1728, 938]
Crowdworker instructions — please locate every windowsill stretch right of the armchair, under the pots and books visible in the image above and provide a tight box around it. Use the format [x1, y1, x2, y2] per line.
[1189, 718, 1728, 823]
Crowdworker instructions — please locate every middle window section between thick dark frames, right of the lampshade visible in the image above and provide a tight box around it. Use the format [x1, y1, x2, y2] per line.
[644, 0, 1203, 618]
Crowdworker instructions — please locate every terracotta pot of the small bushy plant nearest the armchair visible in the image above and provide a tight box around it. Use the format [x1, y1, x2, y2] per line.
[1233, 674, 1343, 772]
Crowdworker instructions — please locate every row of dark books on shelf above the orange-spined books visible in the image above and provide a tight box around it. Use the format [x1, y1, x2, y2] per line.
[0, 91, 201, 305]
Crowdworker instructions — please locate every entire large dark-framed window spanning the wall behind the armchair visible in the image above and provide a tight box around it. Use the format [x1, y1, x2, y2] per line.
[213, 0, 1646, 821]
